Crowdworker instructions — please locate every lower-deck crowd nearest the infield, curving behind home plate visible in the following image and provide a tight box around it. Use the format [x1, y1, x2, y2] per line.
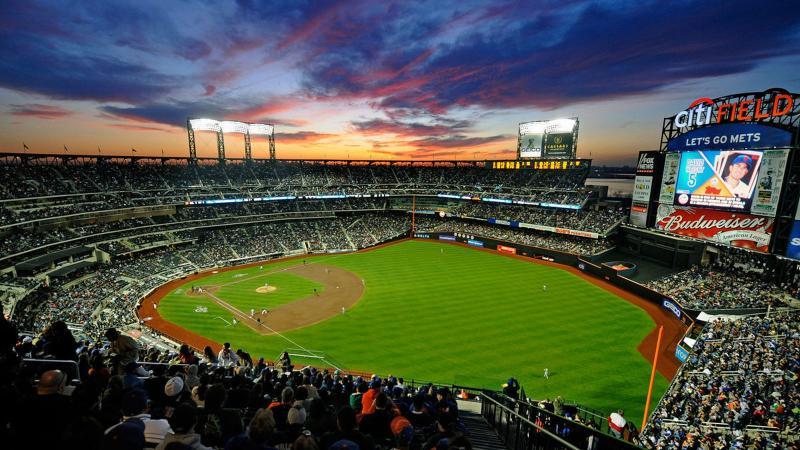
[9, 213, 410, 338]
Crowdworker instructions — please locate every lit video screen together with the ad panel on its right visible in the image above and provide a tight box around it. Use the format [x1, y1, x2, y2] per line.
[662, 150, 788, 216]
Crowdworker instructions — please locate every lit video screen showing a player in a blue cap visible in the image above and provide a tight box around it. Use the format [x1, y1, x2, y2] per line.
[674, 150, 762, 212]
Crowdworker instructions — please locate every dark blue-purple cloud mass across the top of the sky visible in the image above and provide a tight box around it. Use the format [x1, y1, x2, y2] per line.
[0, 0, 800, 130]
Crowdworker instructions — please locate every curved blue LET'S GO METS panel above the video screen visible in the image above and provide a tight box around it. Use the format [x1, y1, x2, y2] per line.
[667, 123, 792, 151]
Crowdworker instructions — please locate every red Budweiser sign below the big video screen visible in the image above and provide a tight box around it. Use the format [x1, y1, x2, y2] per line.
[656, 205, 774, 252]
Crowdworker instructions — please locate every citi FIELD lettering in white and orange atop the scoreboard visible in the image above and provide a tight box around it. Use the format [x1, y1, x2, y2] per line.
[673, 89, 798, 128]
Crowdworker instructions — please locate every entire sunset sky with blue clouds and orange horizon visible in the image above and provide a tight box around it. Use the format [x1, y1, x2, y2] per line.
[0, 0, 800, 164]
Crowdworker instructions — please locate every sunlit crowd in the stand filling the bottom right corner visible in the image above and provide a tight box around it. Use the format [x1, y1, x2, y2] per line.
[640, 312, 800, 449]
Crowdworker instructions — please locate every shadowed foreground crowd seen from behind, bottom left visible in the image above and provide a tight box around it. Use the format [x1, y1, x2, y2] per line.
[0, 312, 472, 450]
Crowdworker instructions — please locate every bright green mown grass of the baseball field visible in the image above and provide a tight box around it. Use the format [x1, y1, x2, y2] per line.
[159, 241, 667, 422]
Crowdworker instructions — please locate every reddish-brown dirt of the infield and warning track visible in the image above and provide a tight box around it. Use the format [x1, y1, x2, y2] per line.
[139, 239, 685, 380]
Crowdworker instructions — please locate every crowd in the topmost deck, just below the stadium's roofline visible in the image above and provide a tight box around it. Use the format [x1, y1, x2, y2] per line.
[0, 161, 589, 229]
